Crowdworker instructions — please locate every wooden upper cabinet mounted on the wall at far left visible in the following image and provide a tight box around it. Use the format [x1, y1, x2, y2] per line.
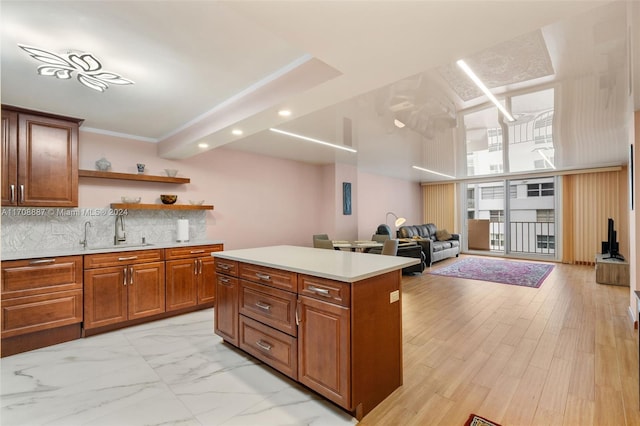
[2, 105, 82, 207]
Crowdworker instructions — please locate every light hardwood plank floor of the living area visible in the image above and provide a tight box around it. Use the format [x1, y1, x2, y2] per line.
[360, 259, 640, 426]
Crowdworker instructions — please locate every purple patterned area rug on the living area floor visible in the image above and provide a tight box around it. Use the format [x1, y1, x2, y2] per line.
[431, 257, 554, 288]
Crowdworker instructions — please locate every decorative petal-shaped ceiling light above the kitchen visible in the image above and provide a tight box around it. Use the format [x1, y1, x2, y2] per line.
[18, 44, 134, 92]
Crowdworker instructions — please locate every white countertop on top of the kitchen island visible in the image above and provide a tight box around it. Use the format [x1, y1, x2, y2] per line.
[212, 246, 420, 283]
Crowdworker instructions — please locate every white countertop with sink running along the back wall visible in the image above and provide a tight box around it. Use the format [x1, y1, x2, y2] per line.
[0, 240, 223, 260]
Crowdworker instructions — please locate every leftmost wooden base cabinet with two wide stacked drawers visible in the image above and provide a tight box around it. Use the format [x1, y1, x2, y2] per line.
[0, 256, 83, 356]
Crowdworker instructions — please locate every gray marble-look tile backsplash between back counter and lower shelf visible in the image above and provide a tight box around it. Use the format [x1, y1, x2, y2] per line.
[0, 207, 206, 252]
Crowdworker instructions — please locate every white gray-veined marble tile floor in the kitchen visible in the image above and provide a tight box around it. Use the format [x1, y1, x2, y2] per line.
[0, 309, 357, 426]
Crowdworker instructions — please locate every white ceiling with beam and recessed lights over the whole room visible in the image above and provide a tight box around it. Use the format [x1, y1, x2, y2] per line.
[0, 0, 640, 181]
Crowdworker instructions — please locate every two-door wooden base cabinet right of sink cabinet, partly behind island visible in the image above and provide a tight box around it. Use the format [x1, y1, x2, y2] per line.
[165, 244, 223, 311]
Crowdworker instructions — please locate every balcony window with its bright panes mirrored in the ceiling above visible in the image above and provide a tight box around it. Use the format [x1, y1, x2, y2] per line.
[462, 89, 559, 257]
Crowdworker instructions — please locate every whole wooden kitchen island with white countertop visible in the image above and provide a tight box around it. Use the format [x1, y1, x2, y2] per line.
[214, 246, 419, 419]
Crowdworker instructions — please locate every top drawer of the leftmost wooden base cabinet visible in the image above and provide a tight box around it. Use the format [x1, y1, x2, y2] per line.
[2, 256, 82, 299]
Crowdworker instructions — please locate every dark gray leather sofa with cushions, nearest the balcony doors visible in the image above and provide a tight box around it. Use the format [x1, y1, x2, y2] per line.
[398, 223, 461, 266]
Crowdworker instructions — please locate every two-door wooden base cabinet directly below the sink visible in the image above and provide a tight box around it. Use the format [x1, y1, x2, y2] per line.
[84, 249, 165, 330]
